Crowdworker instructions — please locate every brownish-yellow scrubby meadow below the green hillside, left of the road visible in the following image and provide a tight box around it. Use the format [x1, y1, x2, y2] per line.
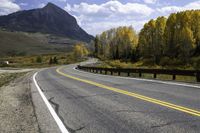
[0, 52, 86, 68]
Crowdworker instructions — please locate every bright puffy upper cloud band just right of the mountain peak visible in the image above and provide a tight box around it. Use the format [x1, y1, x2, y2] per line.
[65, 0, 153, 17]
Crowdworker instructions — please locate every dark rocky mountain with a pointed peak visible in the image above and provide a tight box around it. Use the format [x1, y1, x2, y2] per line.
[0, 3, 93, 42]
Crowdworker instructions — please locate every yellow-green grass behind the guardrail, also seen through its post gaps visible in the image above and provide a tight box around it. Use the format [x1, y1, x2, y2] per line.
[90, 60, 196, 82]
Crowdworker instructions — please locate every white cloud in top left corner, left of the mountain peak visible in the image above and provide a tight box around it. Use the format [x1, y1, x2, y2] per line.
[0, 0, 20, 15]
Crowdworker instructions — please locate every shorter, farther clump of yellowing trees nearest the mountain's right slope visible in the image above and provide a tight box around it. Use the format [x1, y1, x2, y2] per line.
[94, 26, 138, 59]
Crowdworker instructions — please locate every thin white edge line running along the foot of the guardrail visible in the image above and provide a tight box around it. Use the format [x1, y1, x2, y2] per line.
[73, 67, 200, 88]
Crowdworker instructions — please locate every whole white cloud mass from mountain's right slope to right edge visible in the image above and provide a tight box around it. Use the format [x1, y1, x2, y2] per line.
[64, 0, 200, 35]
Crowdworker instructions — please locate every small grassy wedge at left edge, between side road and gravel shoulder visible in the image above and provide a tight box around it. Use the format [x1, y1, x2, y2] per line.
[0, 72, 27, 87]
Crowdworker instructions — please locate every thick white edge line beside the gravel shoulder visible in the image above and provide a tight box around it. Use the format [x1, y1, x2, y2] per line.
[33, 72, 69, 133]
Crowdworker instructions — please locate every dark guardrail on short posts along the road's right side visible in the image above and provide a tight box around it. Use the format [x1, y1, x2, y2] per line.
[77, 65, 200, 82]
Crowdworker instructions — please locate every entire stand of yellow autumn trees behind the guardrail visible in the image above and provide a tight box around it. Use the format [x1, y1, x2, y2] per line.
[94, 10, 200, 67]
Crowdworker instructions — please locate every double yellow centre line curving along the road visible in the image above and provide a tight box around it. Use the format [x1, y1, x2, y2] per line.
[56, 67, 200, 117]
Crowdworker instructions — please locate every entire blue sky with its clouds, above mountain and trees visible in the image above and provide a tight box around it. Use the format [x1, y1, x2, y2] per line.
[0, 0, 200, 35]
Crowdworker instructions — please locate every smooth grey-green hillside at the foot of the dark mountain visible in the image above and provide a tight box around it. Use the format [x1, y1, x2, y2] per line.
[0, 30, 77, 56]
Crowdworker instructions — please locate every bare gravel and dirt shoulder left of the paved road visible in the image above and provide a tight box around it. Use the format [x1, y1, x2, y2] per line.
[0, 74, 40, 133]
